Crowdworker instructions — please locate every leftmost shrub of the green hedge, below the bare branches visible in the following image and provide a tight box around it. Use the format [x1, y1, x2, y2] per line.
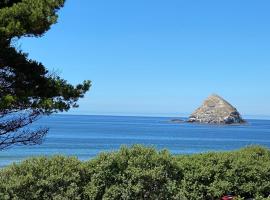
[0, 156, 83, 200]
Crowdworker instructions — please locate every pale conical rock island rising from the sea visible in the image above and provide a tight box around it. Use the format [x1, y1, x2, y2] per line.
[188, 94, 245, 124]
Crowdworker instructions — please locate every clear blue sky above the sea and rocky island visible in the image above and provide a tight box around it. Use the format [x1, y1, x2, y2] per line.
[19, 0, 270, 116]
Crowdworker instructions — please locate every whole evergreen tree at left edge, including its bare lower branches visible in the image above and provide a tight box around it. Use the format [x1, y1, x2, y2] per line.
[0, 0, 90, 150]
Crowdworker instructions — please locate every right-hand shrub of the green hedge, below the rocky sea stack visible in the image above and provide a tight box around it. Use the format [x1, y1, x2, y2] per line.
[178, 147, 270, 200]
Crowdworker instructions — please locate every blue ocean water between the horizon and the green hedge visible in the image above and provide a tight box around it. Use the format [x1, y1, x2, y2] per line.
[0, 115, 270, 167]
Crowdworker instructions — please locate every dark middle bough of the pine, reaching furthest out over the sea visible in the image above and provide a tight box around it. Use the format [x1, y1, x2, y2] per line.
[0, 47, 90, 114]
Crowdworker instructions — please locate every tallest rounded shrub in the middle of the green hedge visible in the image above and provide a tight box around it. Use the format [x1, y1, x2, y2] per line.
[85, 146, 182, 200]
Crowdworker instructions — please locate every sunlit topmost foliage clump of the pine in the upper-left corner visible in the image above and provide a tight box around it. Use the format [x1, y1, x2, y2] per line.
[0, 0, 65, 39]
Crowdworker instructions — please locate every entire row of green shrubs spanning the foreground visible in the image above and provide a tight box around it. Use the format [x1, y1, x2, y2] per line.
[0, 146, 270, 200]
